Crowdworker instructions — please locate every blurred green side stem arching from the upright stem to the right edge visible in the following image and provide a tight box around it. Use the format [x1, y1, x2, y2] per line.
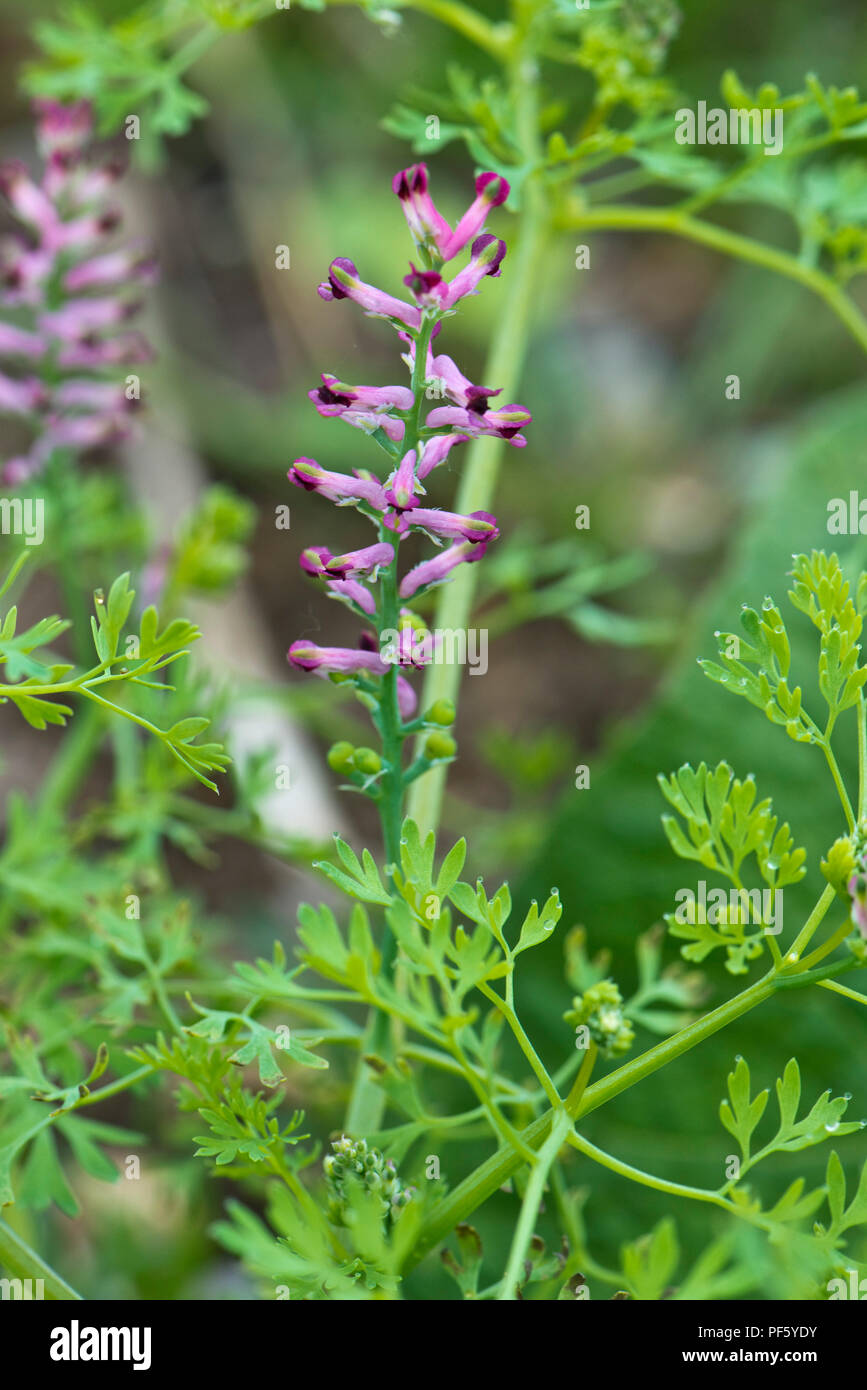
[557, 196, 867, 352]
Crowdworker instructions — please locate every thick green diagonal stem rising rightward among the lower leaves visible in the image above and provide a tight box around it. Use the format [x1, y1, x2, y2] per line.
[407, 972, 775, 1269]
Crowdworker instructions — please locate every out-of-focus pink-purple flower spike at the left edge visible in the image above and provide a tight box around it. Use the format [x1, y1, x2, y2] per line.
[0, 101, 154, 485]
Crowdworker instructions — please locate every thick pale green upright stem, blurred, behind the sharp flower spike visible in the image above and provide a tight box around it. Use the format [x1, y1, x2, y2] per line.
[408, 56, 547, 835]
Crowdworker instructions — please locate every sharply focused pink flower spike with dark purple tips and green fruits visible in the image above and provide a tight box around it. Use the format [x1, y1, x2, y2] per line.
[289, 164, 531, 822]
